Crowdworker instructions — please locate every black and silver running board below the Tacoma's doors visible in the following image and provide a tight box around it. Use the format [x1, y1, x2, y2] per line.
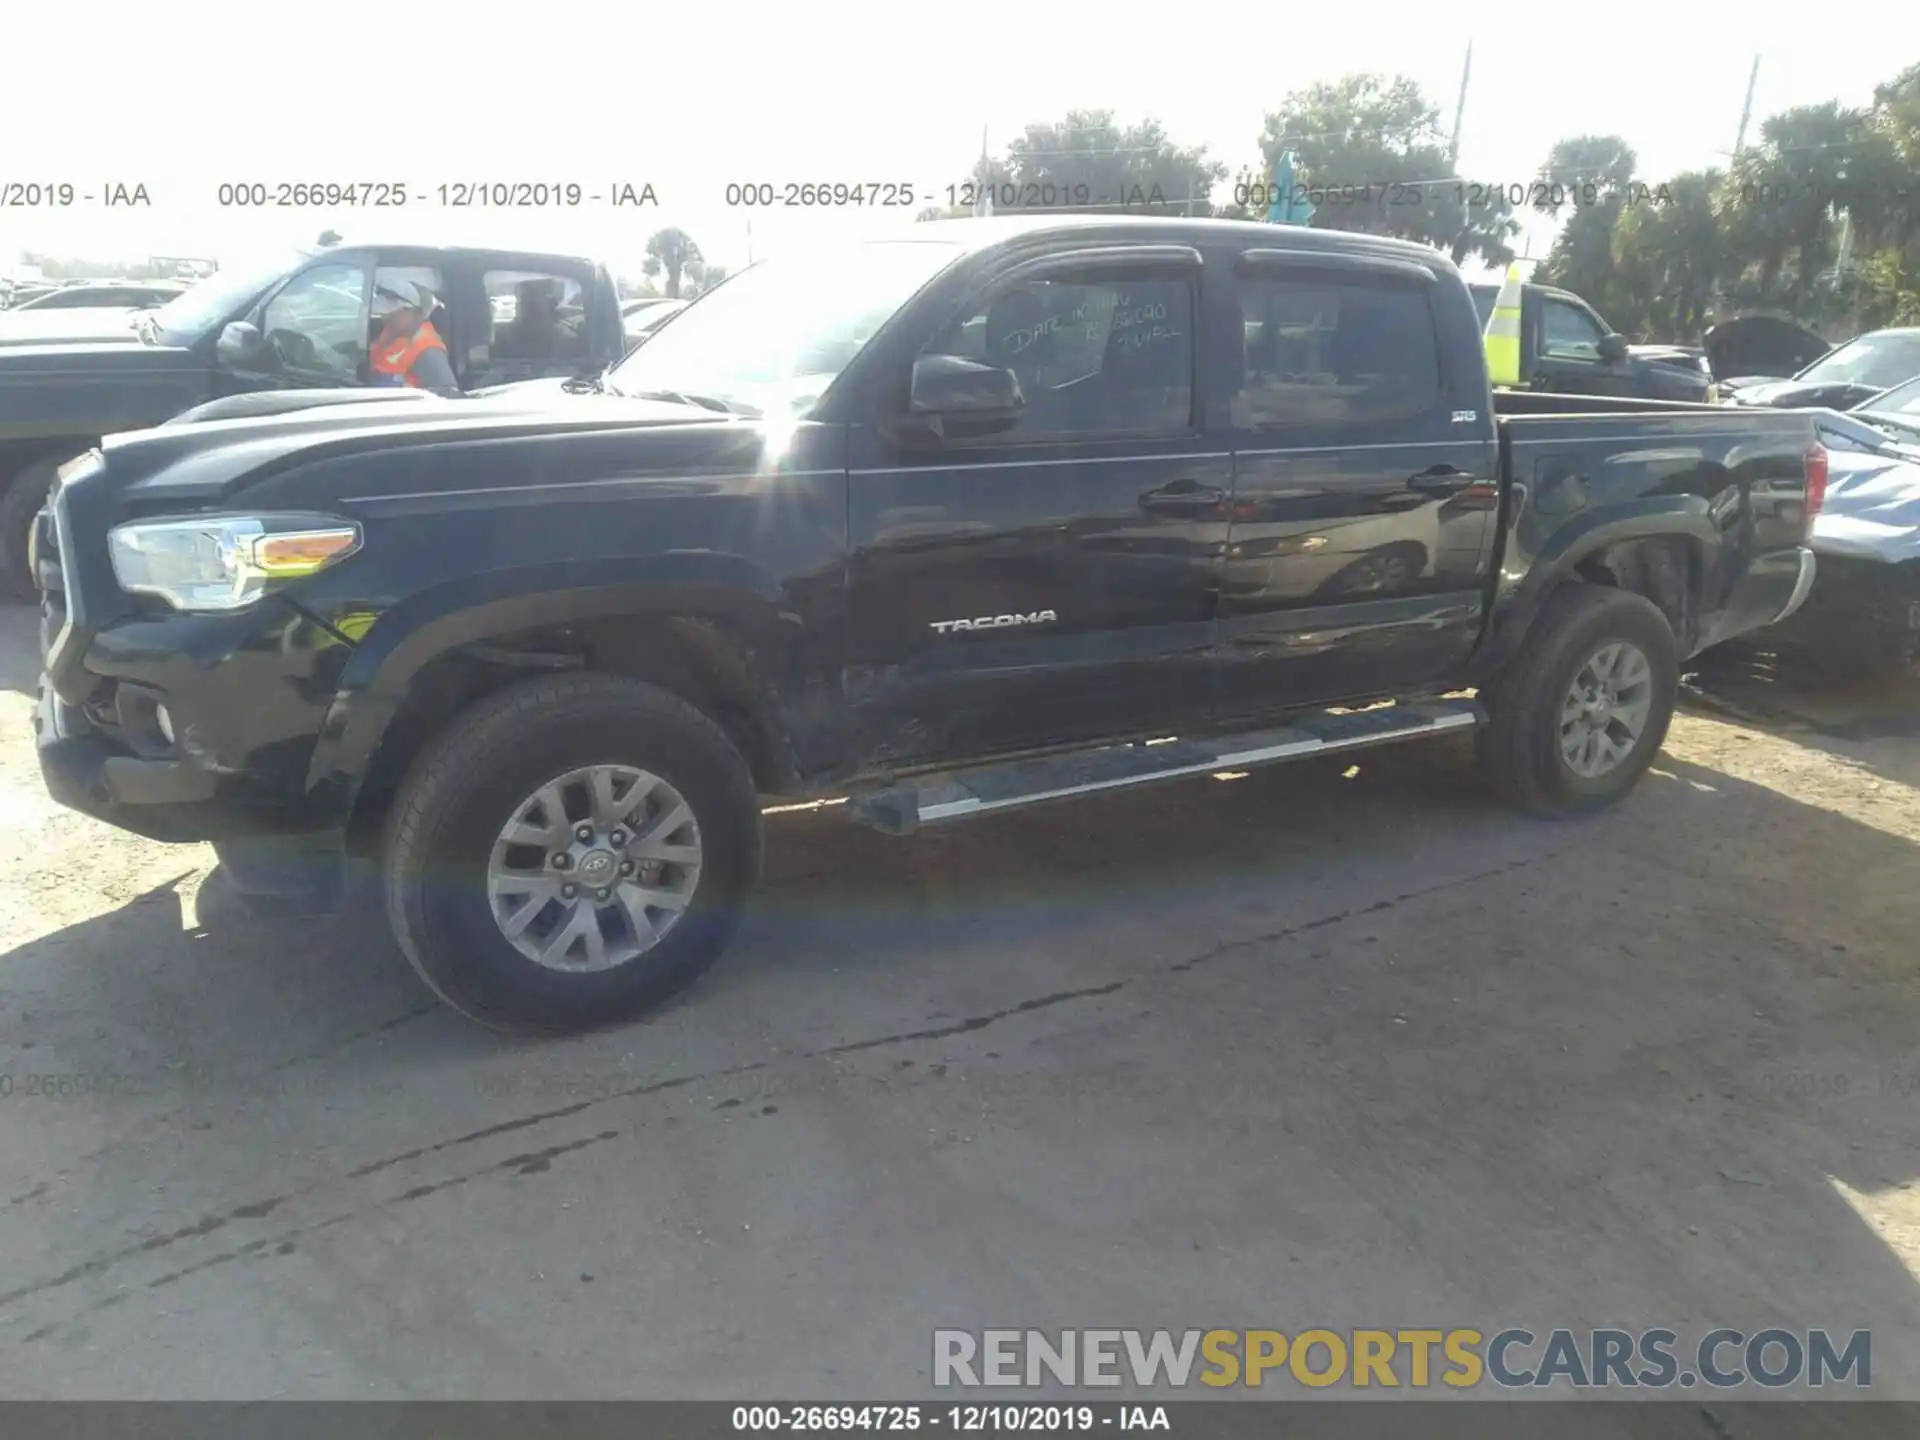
[847, 699, 1486, 835]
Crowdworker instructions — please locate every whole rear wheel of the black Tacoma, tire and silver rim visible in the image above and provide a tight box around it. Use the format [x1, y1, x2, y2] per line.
[1478, 586, 1680, 816]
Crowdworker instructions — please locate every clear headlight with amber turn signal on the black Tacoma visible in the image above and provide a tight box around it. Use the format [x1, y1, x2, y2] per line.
[108, 515, 361, 611]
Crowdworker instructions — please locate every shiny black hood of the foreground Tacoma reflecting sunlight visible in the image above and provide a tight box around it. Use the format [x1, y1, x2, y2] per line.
[90, 386, 751, 507]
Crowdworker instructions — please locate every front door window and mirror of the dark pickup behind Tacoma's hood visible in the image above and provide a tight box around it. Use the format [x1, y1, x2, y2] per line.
[221, 261, 372, 394]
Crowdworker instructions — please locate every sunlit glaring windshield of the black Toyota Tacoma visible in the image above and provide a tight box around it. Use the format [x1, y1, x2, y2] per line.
[607, 240, 960, 415]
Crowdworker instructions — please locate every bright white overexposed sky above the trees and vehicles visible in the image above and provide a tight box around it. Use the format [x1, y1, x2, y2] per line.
[0, 0, 1920, 286]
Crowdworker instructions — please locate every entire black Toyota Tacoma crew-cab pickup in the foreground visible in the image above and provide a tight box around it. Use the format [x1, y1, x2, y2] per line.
[35, 217, 1826, 1031]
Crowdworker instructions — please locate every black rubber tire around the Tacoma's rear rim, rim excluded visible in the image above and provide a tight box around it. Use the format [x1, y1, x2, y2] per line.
[1478, 584, 1680, 818]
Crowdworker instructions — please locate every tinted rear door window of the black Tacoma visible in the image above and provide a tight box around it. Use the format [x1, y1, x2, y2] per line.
[1233, 275, 1440, 430]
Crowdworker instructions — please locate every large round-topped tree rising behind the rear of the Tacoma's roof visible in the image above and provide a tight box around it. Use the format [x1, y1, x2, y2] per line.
[1259, 75, 1521, 265]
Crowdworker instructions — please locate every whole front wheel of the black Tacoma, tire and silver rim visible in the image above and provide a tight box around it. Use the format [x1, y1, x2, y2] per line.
[384, 674, 760, 1033]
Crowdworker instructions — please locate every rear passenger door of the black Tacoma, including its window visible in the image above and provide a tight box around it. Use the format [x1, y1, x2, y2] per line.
[1217, 250, 1498, 726]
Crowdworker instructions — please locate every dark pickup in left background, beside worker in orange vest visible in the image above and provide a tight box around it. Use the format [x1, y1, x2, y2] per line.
[0, 232, 626, 599]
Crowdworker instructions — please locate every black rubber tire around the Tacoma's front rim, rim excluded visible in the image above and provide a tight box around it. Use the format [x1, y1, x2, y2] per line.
[382, 674, 760, 1035]
